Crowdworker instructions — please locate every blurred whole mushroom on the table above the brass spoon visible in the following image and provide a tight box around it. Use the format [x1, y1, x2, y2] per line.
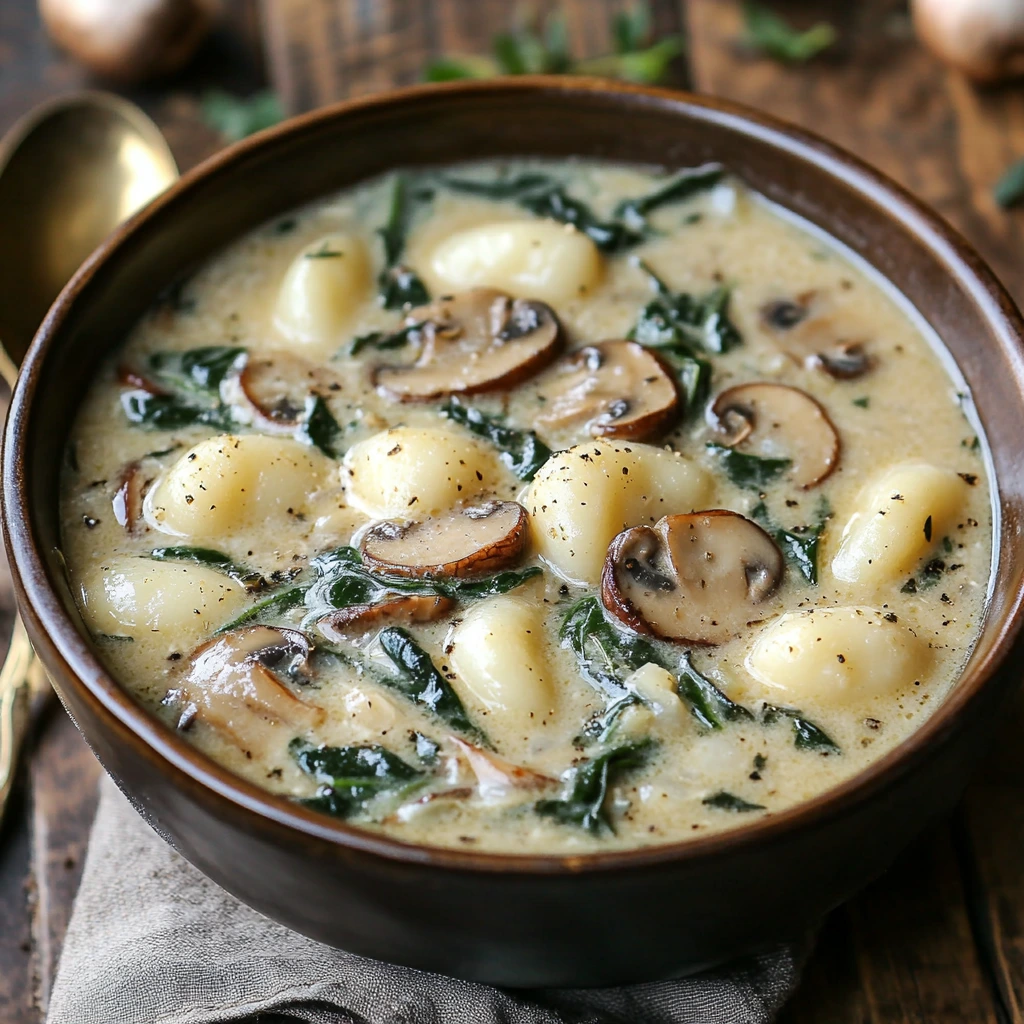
[39, 0, 220, 83]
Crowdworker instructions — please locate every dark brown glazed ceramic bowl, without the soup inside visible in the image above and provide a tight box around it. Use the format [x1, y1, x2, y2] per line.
[3, 79, 1024, 986]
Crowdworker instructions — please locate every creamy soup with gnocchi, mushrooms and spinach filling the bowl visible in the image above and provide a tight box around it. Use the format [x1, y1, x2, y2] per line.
[62, 162, 992, 853]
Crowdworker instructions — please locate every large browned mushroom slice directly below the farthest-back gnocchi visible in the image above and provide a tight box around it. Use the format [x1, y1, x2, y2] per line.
[373, 288, 561, 401]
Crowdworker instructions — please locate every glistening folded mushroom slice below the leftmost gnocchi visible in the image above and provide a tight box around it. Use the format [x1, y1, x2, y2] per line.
[172, 626, 324, 750]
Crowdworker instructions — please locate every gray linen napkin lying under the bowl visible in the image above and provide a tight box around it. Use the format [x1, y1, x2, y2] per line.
[47, 778, 806, 1024]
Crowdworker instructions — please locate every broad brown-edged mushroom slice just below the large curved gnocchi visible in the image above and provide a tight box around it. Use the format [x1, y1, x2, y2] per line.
[601, 509, 783, 644]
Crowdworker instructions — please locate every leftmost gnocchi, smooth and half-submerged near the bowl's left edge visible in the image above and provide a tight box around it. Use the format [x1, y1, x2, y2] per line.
[77, 556, 247, 649]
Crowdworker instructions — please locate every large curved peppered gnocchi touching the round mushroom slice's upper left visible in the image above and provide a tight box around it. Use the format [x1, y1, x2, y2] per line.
[526, 440, 713, 584]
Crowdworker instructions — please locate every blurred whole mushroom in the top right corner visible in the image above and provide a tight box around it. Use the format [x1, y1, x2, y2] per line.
[911, 0, 1024, 82]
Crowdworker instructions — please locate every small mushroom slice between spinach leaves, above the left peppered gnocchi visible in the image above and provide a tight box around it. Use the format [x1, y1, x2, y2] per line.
[226, 352, 332, 434]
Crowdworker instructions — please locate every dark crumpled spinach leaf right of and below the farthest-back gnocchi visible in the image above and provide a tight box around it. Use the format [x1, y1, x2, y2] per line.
[629, 260, 742, 354]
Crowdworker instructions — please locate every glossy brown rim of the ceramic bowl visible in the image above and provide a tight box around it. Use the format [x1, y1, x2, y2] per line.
[8, 76, 1024, 876]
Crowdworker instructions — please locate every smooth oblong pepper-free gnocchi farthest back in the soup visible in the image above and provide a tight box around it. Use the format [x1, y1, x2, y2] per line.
[426, 220, 603, 303]
